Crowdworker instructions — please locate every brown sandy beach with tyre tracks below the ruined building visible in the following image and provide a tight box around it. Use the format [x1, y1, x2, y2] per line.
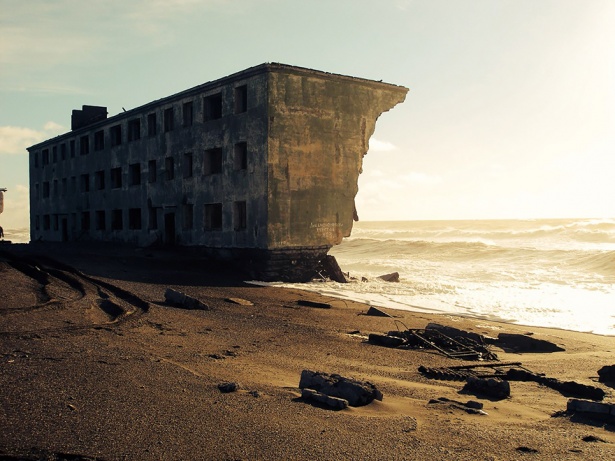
[0, 244, 615, 460]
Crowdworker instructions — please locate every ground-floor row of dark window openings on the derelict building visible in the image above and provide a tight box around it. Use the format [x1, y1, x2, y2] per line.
[35, 201, 248, 231]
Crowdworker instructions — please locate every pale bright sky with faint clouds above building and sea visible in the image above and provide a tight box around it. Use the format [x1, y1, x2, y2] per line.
[0, 0, 615, 228]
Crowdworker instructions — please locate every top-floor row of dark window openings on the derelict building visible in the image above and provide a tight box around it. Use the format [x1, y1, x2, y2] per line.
[34, 85, 248, 168]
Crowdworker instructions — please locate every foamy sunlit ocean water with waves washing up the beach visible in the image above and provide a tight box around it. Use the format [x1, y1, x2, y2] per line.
[287, 219, 615, 335]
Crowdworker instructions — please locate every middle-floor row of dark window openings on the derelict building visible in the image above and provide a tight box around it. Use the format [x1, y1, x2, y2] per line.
[35, 142, 248, 198]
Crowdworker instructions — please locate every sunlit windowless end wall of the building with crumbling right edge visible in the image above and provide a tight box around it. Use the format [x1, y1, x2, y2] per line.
[267, 69, 408, 248]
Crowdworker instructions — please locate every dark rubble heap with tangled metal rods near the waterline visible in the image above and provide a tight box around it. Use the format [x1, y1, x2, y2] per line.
[369, 320, 498, 360]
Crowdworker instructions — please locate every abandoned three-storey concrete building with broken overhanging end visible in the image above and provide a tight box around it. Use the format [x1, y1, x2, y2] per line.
[28, 63, 408, 280]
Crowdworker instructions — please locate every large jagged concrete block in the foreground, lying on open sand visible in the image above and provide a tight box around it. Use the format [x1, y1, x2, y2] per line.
[299, 370, 382, 407]
